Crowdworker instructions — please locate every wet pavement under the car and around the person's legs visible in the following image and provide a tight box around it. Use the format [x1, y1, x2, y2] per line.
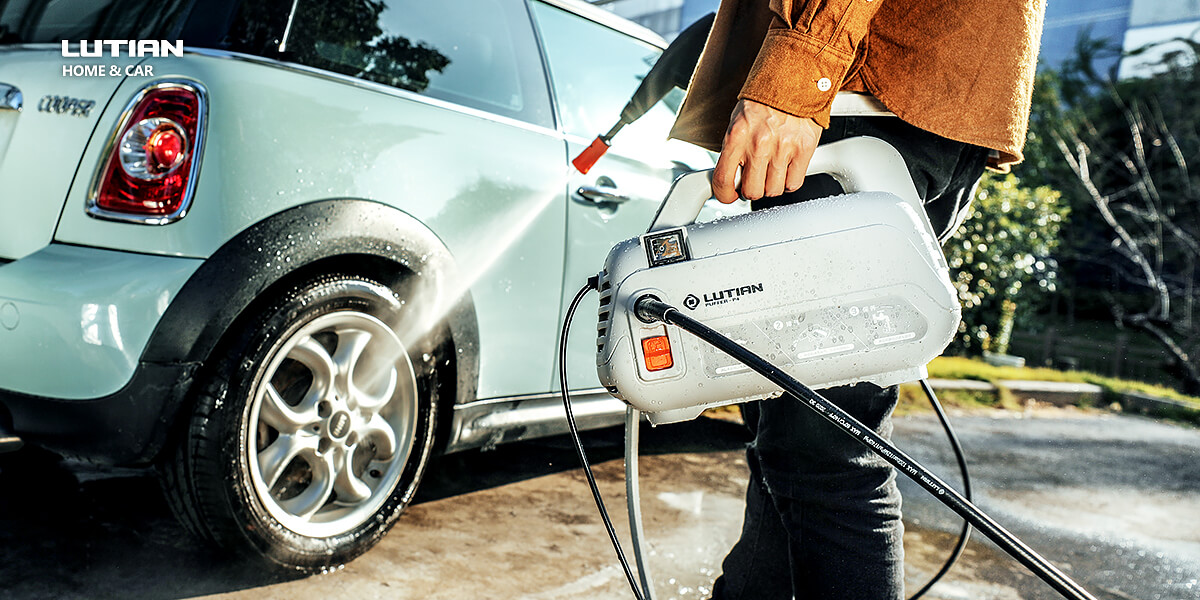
[0, 410, 1200, 600]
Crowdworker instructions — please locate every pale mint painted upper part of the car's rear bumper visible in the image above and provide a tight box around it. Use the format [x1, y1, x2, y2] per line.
[0, 244, 202, 400]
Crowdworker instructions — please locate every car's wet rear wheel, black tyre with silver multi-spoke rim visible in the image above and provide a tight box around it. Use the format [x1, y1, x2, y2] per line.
[158, 275, 449, 572]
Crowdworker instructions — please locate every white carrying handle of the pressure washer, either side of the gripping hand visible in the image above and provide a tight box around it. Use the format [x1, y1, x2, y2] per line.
[648, 136, 920, 232]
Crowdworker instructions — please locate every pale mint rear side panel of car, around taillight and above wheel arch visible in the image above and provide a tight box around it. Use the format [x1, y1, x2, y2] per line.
[58, 54, 565, 397]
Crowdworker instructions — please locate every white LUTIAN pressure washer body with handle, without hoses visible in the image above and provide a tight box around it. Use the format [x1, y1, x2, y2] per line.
[596, 138, 960, 424]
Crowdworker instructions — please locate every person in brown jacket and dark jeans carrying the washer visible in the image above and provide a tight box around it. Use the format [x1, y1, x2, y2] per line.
[671, 0, 1045, 600]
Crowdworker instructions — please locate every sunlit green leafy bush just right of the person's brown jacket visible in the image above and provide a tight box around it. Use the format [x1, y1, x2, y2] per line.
[946, 174, 1069, 354]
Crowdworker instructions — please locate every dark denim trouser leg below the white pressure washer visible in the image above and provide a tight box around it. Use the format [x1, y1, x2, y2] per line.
[713, 384, 904, 600]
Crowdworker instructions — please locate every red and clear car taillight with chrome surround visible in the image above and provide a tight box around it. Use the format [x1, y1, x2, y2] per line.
[88, 82, 206, 224]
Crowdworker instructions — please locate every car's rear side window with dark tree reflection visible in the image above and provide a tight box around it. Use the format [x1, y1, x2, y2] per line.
[227, 0, 553, 126]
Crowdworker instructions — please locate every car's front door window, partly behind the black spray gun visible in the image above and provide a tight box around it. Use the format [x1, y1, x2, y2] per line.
[533, 2, 683, 148]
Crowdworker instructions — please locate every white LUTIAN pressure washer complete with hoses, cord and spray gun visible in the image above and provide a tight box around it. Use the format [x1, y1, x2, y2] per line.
[559, 18, 1096, 600]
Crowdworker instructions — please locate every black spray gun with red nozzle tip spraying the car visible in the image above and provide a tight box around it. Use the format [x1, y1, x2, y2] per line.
[571, 13, 716, 174]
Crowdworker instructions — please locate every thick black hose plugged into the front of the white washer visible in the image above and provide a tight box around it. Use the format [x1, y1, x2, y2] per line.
[635, 296, 1096, 600]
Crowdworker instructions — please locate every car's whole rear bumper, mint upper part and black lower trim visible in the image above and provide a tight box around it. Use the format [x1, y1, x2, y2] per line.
[0, 244, 203, 463]
